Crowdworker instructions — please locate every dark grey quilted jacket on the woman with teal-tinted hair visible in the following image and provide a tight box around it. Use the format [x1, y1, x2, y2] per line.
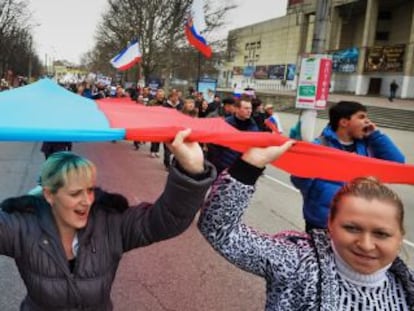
[0, 165, 215, 311]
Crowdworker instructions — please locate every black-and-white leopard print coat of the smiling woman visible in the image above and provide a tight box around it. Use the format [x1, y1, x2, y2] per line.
[198, 172, 414, 311]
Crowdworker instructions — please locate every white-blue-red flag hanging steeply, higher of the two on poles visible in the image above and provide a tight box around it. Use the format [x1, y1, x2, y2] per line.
[185, 0, 212, 58]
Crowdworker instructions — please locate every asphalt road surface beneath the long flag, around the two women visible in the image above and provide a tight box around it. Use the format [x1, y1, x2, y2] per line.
[0, 113, 414, 311]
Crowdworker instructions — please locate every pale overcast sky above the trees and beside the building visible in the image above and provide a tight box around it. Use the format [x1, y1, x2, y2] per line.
[29, 0, 287, 63]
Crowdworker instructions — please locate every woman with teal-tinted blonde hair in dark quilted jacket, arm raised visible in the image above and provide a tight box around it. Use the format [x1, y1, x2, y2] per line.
[0, 129, 216, 311]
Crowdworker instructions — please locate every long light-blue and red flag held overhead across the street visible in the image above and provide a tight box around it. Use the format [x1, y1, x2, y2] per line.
[0, 79, 414, 185]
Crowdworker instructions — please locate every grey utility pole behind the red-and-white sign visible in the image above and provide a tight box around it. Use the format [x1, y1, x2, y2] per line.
[301, 0, 332, 141]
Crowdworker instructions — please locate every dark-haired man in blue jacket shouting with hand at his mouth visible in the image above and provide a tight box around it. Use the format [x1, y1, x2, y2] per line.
[291, 101, 405, 232]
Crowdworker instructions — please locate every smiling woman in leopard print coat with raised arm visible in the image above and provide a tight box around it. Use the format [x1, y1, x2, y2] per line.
[198, 141, 414, 311]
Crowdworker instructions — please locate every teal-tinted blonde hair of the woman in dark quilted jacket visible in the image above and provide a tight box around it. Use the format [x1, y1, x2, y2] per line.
[40, 151, 96, 193]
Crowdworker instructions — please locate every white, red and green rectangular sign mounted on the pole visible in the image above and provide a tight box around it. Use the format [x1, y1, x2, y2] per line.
[296, 55, 332, 110]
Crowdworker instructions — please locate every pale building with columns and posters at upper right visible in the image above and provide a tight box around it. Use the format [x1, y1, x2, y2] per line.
[220, 0, 414, 98]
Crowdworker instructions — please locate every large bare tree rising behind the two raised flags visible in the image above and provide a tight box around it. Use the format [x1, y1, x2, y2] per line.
[84, 0, 235, 89]
